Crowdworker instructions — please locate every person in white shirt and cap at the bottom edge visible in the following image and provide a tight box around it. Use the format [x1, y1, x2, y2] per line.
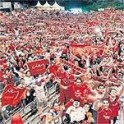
[66, 100, 85, 124]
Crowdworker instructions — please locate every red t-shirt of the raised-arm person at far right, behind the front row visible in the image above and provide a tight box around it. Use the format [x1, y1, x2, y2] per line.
[108, 96, 119, 118]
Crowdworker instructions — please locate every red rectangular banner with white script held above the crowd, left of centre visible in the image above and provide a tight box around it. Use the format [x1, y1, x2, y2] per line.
[28, 59, 49, 75]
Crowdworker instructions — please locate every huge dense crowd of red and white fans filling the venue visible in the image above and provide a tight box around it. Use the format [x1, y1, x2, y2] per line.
[0, 8, 124, 124]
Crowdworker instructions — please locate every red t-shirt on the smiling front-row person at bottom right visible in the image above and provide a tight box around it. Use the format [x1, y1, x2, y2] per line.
[97, 108, 112, 124]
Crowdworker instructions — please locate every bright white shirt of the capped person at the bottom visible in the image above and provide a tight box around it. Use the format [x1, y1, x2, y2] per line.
[66, 106, 85, 122]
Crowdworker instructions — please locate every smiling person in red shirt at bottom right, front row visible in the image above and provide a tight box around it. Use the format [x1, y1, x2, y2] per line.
[96, 99, 112, 124]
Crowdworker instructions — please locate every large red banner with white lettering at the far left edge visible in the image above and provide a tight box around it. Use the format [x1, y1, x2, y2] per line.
[1, 84, 26, 106]
